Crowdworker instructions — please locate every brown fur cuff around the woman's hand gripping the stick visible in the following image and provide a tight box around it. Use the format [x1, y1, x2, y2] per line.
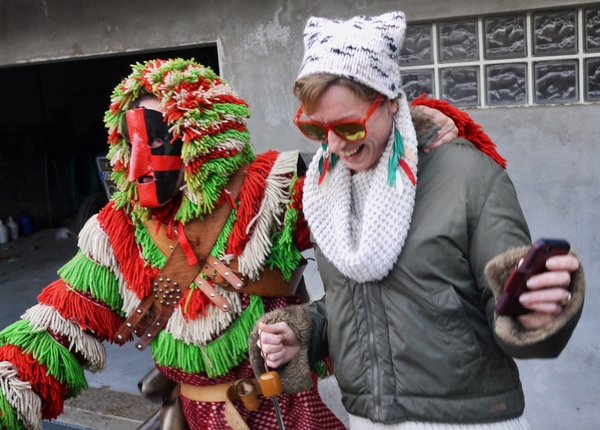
[248, 305, 312, 394]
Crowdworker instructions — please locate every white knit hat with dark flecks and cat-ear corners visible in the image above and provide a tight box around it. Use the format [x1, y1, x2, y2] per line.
[298, 12, 406, 99]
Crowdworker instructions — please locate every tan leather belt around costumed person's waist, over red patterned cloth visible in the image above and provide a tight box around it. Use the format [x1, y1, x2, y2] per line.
[180, 378, 262, 430]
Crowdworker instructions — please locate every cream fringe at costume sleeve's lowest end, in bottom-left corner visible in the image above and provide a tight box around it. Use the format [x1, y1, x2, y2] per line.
[0, 361, 42, 430]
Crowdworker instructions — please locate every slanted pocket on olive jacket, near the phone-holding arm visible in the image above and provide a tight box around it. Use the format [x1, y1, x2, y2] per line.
[431, 285, 483, 367]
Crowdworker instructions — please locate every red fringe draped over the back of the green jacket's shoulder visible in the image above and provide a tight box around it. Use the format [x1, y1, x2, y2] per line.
[411, 94, 506, 169]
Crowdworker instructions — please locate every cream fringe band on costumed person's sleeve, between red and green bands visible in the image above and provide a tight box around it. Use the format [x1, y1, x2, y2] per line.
[21, 304, 106, 373]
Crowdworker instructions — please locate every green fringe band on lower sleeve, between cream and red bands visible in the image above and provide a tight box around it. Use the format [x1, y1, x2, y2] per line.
[0, 320, 88, 397]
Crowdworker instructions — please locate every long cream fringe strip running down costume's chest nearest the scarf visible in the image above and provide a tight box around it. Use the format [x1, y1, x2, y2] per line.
[238, 151, 299, 280]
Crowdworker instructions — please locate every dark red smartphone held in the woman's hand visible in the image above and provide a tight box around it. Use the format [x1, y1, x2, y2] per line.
[496, 239, 571, 315]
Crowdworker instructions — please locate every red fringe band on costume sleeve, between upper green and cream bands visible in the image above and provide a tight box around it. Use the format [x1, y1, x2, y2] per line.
[38, 279, 125, 343]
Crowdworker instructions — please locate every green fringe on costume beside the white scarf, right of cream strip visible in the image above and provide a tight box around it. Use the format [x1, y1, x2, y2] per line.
[265, 173, 302, 281]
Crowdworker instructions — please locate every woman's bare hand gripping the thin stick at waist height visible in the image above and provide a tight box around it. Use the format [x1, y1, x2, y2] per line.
[256, 322, 301, 368]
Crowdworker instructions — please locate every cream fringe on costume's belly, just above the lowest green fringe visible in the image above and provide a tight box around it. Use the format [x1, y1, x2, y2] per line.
[165, 286, 242, 348]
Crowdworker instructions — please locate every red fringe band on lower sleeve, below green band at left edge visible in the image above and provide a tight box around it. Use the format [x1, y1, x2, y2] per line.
[0, 344, 69, 419]
